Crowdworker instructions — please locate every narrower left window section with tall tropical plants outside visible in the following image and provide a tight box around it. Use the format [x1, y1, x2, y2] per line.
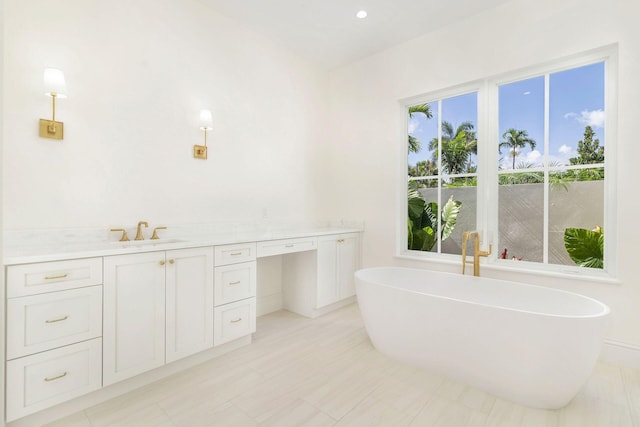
[407, 92, 478, 254]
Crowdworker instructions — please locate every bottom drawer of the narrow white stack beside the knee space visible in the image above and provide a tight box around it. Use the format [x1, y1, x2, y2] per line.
[213, 298, 256, 346]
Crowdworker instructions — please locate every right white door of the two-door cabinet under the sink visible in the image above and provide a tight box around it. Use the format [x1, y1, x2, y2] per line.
[166, 247, 213, 363]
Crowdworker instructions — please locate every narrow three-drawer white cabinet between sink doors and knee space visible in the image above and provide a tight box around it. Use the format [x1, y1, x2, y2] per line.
[213, 243, 257, 346]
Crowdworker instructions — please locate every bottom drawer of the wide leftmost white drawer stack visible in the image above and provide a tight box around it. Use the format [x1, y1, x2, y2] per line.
[7, 338, 102, 421]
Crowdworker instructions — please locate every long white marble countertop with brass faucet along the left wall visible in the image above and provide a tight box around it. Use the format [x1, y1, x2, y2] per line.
[3, 224, 363, 265]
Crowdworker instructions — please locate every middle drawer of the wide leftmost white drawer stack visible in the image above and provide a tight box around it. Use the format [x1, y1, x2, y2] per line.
[7, 286, 102, 360]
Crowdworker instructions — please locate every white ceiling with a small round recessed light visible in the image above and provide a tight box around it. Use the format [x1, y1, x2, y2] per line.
[201, 0, 510, 69]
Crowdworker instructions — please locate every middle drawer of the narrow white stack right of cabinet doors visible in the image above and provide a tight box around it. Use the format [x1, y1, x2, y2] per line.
[214, 261, 256, 307]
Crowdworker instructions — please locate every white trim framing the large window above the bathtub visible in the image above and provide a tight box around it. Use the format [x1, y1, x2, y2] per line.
[396, 44, 618, 283]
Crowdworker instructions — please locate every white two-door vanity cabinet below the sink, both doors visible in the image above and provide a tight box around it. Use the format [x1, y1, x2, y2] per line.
[103, 247, 213, 385]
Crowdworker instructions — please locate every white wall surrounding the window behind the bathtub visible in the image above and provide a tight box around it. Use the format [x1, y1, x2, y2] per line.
[318, 0, 640, 366]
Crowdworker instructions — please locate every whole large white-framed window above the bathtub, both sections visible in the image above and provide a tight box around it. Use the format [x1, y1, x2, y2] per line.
[398, 48, 615, 276]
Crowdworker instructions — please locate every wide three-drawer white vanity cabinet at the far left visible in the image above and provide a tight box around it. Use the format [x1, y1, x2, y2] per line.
[6, 258, 102, 421]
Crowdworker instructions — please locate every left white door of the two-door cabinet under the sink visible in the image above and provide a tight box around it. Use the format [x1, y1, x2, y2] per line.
[103, 252, 165, 386]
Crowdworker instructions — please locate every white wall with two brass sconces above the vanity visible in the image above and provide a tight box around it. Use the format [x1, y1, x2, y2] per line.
[3, 0, 326, 230]
